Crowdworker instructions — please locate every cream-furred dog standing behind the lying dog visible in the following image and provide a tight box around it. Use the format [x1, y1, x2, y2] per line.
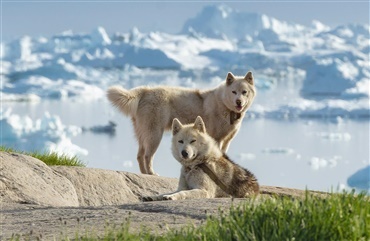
[107, 72, 256, 174]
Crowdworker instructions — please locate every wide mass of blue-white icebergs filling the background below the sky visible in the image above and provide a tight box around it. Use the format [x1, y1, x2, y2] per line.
[0, 5, 370, 119]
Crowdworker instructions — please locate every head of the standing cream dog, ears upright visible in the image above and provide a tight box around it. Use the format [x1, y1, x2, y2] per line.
[223, 71, 256, 113]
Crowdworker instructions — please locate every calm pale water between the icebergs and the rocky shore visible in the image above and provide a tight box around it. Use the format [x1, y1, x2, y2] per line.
[3, 98, 370, 191]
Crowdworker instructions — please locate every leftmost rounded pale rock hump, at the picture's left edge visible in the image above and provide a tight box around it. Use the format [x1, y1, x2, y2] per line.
[0, 152, 79, 207]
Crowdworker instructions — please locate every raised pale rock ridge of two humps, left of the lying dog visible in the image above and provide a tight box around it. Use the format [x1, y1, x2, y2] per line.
[0, 152, 178, 207]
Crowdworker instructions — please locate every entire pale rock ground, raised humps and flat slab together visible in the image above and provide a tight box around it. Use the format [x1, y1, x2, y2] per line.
[0, 152, 312, 240]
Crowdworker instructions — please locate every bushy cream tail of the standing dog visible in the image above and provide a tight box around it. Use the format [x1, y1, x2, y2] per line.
[107, 85, 140, 117]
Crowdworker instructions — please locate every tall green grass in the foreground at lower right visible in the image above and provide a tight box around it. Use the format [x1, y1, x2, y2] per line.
[79, 192, 370, 241]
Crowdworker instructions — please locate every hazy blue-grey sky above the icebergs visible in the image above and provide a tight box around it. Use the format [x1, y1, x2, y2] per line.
[1, 0, 369, 40]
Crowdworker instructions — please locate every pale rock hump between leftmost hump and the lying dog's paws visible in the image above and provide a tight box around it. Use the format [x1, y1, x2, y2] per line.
[52, 166, 178, 206]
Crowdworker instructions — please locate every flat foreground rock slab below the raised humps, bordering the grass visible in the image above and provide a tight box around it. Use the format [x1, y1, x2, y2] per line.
[1, 199, 247, 240]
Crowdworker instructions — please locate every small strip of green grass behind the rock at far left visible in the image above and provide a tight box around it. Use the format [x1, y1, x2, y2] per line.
[0, 146, 86, 167]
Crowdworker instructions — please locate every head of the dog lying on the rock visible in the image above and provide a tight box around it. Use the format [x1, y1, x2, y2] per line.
[172, 116, 216, 166]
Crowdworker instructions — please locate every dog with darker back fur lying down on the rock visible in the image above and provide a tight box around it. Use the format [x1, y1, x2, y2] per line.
[143, 117, 259, 201]
